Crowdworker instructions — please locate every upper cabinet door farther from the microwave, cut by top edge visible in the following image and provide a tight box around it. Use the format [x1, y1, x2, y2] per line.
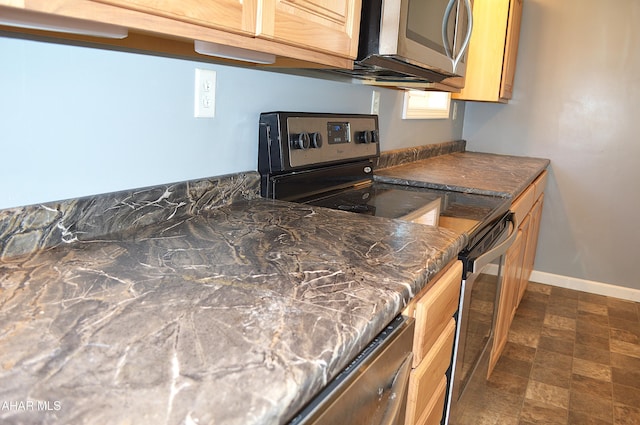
[94, 0, 258, 35]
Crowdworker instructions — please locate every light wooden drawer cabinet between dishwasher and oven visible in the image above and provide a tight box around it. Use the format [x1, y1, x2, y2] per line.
[404, 261, 462, 425]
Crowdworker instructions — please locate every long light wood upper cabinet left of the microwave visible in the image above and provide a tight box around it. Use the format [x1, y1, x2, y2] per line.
[0, 0, 362, 69]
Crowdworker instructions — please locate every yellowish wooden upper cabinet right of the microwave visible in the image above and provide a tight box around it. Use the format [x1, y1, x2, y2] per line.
[452, 0, 523, 103]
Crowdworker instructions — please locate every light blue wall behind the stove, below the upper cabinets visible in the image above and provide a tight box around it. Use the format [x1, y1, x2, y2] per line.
[0, 37, 464, 208]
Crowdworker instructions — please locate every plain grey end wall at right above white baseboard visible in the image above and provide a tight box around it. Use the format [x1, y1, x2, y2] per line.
[463, 0, 640, 290]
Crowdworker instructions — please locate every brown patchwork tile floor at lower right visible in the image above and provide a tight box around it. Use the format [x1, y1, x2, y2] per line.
[450, 282, 640, 425]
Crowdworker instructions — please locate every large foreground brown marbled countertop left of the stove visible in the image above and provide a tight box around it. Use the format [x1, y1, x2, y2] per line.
[0, 197, 465, 425]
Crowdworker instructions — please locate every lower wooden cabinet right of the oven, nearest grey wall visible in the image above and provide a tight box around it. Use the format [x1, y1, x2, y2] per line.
[488, 171, 547, 375]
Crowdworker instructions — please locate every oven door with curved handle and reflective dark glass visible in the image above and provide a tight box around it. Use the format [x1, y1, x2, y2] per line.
[448, 213, 518, 424]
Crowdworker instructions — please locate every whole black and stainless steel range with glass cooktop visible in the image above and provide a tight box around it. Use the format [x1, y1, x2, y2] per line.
[258, 112, 517, 424]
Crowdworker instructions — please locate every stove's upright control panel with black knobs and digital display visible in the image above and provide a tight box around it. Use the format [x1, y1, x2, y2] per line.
[258, 112, 380, 172]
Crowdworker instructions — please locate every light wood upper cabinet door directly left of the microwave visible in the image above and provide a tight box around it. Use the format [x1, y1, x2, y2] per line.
[258, 0, 361, 58]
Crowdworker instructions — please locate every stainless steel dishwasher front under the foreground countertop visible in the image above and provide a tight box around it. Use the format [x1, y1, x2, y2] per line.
[290, 316, 414, 425]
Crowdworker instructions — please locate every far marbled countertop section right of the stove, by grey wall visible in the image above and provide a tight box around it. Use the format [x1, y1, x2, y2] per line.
[375, 151, 550, 198]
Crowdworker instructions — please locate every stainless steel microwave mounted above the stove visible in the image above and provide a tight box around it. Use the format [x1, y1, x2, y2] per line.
[338, 0, 473, 91]
